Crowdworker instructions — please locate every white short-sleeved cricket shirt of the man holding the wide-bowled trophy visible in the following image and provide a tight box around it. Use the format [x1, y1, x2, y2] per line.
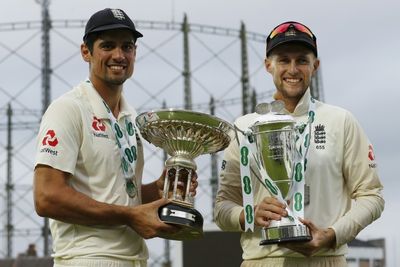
[36, 82, 148, 260]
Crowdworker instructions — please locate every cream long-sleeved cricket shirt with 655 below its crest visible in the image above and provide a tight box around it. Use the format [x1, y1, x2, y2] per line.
[214, 90, 384, 260]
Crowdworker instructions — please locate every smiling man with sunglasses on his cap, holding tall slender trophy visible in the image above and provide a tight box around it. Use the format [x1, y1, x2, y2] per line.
[214, 21, 384, 267]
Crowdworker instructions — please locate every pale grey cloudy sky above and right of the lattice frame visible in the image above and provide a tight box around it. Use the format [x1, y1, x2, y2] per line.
[0, 0, 400, 266]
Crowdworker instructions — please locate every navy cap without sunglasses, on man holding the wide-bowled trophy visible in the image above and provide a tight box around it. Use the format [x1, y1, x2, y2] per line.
[83, 8, 143, 41]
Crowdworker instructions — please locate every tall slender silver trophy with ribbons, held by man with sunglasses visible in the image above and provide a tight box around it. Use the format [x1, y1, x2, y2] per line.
[238, 101, 311, 245]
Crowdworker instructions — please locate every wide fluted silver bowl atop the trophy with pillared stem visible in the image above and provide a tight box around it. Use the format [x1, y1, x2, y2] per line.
[136, 109, 234, 158]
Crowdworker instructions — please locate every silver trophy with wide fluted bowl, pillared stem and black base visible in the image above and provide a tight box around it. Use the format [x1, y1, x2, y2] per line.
[136, 109, 234, 240]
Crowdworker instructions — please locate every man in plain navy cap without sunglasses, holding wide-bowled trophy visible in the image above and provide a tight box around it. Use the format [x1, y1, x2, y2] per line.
[34, 8, 197, 267]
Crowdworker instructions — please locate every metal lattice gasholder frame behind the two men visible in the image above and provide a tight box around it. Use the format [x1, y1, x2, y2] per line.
[0, 3, 320, 266]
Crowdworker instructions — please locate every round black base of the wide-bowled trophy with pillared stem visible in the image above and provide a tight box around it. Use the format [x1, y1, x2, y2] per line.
[158, 203, 204, 240]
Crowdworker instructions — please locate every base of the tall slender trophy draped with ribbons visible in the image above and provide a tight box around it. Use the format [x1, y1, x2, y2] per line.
[260, 224, 312, 246]
